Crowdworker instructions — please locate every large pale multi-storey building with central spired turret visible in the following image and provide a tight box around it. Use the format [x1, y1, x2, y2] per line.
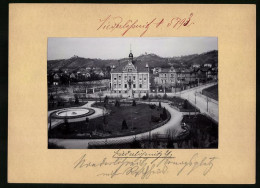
[111, 52, 150, 97]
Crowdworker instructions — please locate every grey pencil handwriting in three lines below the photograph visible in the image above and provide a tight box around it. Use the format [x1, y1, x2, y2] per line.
[73, 149, 217, 179]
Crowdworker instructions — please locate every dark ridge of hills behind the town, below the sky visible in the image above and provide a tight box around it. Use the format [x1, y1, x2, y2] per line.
[47, 50, 218, 71]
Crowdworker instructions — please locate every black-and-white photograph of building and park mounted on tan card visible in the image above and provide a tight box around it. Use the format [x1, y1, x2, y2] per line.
[47, 37, 219, 149]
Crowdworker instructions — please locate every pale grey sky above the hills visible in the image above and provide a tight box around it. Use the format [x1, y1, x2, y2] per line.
[48, 37, 218, 60]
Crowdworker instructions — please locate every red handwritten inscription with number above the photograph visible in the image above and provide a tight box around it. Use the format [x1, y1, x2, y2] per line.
[97, 13, 194, 37]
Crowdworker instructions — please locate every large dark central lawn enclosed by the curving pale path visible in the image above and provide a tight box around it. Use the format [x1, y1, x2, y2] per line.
[49, 103, 170, 138]
